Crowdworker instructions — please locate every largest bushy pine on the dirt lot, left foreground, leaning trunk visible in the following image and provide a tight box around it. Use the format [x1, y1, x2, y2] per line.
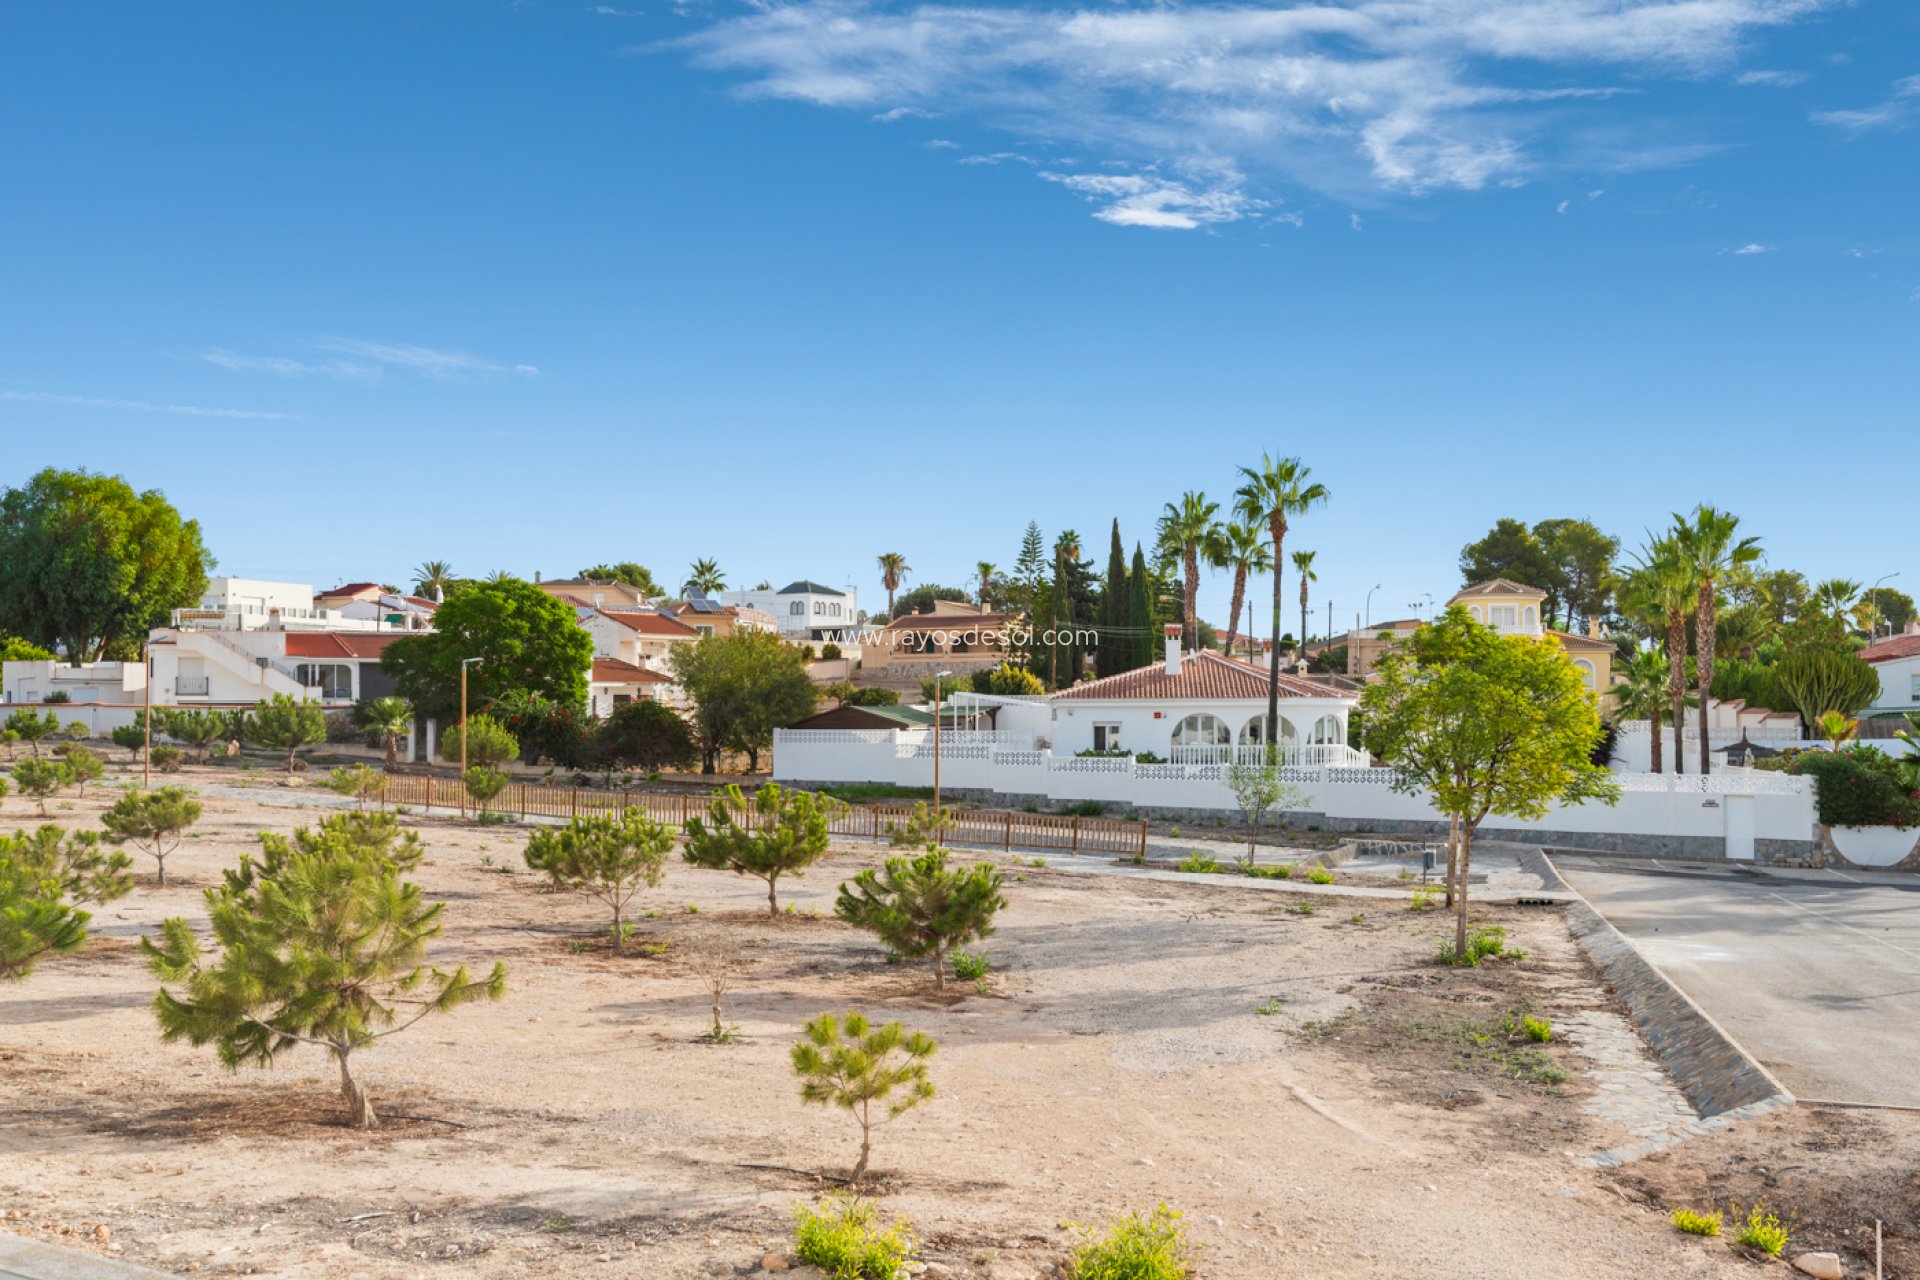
[142, 825, 507, 1128]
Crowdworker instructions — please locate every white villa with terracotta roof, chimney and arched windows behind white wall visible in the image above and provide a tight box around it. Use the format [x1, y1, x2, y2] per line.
[1052, 626, 1367, 766]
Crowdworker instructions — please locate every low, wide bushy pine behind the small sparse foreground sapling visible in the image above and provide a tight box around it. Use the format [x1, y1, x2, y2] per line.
[833, 846, 1006, 988]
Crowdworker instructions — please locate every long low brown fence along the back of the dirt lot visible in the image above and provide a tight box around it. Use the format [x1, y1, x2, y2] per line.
[386, 773, 1146, 856]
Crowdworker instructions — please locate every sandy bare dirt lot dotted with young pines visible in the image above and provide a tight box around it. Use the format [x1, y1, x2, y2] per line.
[0, 771, 1889, 1280]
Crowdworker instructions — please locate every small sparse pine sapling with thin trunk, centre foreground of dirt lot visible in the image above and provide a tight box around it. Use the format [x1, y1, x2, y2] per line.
[793, 1009, 937, 1184]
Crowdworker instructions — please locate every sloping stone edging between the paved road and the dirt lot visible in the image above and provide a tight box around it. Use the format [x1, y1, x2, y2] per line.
[1523, 852, 1793, 1167]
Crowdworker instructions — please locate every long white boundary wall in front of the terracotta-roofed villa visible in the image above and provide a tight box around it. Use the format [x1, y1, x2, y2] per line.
[774, 729, 1814, 858]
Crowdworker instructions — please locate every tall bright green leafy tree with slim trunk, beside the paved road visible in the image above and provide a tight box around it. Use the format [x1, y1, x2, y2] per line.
[1359, 604, 1620, 960]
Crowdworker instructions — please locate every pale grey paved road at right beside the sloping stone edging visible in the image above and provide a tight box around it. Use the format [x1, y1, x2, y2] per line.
[1553, 856, 1920, 1107]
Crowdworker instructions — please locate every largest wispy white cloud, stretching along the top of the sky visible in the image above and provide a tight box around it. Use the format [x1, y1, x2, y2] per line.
[680, 0, 1837, 225]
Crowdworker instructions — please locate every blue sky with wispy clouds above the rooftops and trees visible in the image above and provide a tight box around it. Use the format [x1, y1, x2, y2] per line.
[0, 0, 1920, 628]
